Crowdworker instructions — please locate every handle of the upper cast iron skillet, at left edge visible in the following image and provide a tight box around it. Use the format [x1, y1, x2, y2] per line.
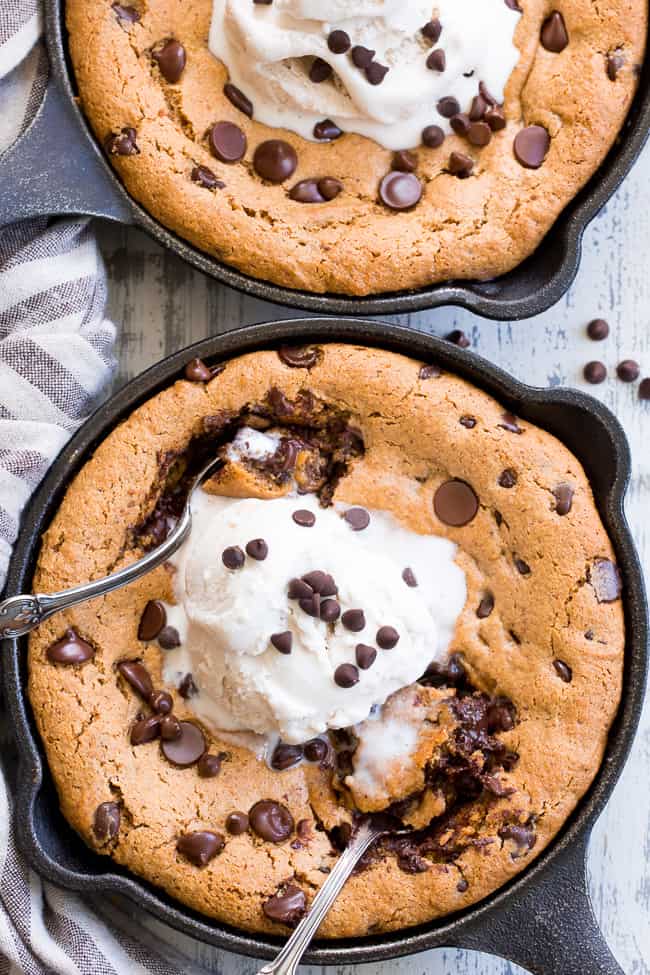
[0, 78, 132, 227]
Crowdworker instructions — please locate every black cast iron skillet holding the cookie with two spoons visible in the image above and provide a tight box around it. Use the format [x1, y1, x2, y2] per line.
[0, 319, 648, 975]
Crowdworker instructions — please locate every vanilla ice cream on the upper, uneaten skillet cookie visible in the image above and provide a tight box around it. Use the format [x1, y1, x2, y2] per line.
[209, 0, 519, 149]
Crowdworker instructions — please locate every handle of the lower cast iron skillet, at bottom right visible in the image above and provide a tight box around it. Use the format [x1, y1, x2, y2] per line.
[454, 840, 625, 975]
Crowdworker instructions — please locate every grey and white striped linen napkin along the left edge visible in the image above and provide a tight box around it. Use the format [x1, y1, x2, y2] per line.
[0, 7, 180, 975]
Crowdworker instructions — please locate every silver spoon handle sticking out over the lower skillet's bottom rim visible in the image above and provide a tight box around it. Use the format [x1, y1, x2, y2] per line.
[257, 820, 384, 975]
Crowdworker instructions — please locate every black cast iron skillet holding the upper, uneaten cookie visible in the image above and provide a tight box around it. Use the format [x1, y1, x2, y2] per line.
[0, 0, 650, 319]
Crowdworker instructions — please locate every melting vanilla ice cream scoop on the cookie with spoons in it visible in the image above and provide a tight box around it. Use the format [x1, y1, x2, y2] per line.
[164, 492, 466, 743]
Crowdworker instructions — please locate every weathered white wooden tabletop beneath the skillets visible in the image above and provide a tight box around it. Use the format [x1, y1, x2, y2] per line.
[95, 137, 650, 975]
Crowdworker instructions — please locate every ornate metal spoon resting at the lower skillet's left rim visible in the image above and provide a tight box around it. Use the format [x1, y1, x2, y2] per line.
[0, 457, 225, 639]
